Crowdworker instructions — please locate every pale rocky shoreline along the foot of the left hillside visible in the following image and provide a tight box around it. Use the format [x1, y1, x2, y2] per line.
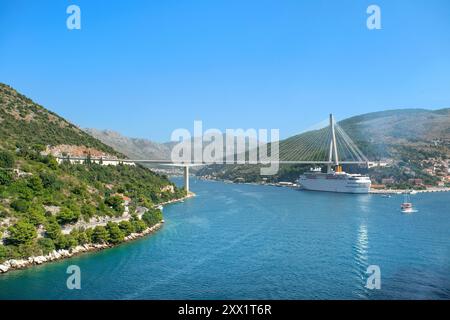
[0, 193, 194, 274]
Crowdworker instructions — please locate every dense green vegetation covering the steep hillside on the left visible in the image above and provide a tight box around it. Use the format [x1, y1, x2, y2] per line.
[0, 84, 185, 263]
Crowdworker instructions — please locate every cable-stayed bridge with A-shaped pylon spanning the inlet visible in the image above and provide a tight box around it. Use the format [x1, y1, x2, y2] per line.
[56, 114, 369, 192]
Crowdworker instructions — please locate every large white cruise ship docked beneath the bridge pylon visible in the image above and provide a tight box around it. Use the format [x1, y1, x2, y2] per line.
[298, 166, 371, 193]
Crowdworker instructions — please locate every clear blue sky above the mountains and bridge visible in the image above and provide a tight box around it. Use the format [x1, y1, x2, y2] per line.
[0, 0, 450, 141]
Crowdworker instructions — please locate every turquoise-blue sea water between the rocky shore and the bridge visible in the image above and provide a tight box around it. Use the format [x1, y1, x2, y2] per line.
[0, 180, 450, 299]
